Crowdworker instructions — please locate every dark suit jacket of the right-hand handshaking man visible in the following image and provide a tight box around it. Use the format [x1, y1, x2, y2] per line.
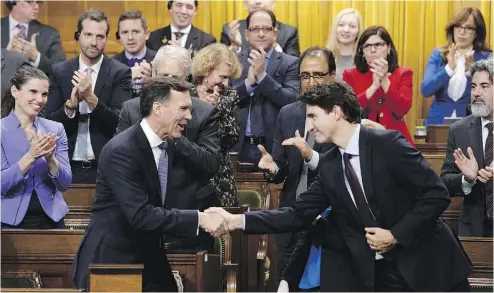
[245, 127, 472, 291]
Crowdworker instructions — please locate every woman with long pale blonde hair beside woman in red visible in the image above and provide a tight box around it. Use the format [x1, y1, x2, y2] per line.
[326, 8, 364, 81]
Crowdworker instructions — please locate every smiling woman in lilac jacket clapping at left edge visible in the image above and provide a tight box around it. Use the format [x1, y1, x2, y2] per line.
[1, 66, 72, 229]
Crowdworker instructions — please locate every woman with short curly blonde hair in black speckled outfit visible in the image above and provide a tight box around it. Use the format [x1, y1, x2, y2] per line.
[192, 44, 242, 207]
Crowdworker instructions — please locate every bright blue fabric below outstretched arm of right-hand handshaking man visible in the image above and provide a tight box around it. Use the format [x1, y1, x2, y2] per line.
[298, 206, 331, 289]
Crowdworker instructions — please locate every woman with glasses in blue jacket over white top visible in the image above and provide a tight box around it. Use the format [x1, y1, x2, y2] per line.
[420, 7, 492, 124]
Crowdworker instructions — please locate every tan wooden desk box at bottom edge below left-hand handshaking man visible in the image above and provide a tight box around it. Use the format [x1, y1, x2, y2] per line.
[89, 264, 144, 292]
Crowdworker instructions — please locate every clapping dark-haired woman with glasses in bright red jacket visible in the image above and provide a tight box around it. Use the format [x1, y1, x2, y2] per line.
[343, 26, 413, 145]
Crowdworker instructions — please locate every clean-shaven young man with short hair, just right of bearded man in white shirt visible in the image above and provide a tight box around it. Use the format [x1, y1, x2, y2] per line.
[113, 10, 156, 97]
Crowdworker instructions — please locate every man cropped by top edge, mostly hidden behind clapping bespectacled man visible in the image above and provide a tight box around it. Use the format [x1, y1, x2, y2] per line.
[221, 0, 300, 57]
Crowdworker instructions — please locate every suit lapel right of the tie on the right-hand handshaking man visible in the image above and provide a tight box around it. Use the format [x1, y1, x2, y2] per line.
[359, 127, 381, 223]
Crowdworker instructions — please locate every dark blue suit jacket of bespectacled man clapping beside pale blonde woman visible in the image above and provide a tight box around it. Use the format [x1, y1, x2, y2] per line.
[232, 50, 300, 152]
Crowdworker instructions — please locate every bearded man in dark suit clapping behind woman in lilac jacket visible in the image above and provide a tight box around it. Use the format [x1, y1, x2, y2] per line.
[45, 9, 132, 184]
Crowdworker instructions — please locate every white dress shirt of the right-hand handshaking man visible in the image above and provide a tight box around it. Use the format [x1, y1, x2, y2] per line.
[340, 124, 383, 260]
